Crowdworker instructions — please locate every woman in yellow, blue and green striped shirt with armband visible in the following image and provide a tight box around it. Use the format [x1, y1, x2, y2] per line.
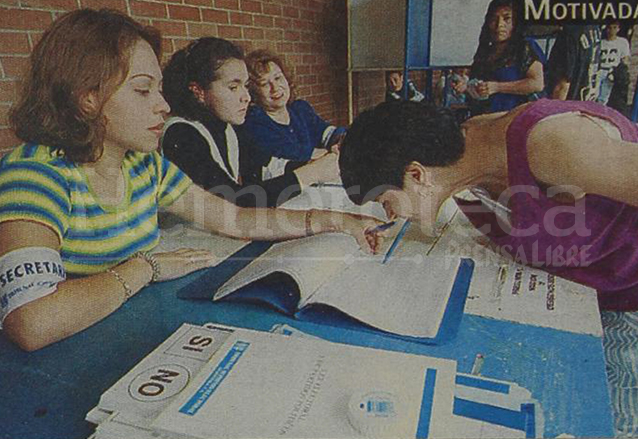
[0, 9, 377, 351]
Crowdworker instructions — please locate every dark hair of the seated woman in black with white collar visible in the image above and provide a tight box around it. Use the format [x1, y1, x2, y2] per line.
[163, 37, 244, 121]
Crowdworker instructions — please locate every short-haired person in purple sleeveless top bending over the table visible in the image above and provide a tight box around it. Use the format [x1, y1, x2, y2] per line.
[339, 99, 638, 310]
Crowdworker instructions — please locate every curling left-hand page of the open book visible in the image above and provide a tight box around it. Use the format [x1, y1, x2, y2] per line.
[213, 233, 363, 302]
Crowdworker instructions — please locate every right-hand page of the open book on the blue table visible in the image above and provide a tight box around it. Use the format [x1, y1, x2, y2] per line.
[305, 255, 459, 337]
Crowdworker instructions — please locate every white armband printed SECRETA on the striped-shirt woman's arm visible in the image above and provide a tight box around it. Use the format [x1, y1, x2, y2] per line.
[0, 247, 66, 329]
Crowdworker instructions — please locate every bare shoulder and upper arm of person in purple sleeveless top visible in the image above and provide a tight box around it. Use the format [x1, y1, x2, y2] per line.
[528, 115, 638, 206]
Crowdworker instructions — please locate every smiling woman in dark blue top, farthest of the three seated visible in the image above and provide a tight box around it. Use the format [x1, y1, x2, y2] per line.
[244, 50, 345, 181]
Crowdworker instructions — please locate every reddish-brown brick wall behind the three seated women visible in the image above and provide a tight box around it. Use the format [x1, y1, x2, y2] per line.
[0, 0, 348, 155]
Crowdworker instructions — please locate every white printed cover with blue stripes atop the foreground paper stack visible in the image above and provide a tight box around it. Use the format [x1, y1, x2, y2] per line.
[152, 333, 456, 438]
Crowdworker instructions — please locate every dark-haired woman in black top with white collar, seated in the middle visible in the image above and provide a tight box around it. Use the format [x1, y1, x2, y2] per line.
[162, 37, 337, 207]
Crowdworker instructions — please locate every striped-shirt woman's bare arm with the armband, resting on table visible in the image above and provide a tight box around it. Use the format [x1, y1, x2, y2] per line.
[0, 221, 152, 351]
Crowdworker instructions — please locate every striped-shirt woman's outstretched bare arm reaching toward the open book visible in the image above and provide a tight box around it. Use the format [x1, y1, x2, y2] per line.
[168, 185, 380, 251]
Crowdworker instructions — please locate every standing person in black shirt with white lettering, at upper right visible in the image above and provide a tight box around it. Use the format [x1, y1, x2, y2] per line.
[547, 25, 601, 101]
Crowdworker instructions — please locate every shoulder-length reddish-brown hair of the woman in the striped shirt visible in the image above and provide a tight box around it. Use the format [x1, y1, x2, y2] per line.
[10, 9, 161, 163]
